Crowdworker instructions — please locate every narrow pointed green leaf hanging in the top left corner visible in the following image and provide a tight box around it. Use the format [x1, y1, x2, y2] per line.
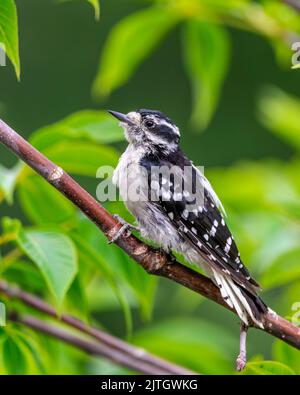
[0, 0, 20, 79]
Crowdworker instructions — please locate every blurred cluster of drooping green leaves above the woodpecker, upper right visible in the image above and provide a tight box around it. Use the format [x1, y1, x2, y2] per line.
[93, 0, 300, 130]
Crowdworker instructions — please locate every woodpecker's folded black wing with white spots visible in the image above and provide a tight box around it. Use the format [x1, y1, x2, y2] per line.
[141, 152, 259, 293]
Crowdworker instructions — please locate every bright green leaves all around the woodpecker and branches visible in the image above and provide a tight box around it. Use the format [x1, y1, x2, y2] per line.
[0, 0, 300, 374]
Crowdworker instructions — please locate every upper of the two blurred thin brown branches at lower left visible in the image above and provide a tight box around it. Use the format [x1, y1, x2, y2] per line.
[0, 280, 196, 375]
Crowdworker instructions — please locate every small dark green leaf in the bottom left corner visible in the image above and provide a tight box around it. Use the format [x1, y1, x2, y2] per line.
[2, 336, 27, 374]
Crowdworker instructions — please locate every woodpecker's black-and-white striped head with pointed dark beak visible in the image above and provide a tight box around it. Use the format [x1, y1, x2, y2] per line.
[109, 109, 180, 151]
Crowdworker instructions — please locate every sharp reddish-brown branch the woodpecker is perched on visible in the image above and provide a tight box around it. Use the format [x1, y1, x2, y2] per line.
[0, 120, 300, 349]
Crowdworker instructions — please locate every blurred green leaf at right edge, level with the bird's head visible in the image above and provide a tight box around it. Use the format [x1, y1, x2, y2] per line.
[259, 87, 300, 150]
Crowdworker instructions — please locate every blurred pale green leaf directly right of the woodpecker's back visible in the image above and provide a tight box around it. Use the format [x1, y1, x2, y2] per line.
[209, 160, 300, 217]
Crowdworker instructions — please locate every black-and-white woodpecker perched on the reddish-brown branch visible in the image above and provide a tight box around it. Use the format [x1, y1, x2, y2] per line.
[109, 109, 268, 371]
